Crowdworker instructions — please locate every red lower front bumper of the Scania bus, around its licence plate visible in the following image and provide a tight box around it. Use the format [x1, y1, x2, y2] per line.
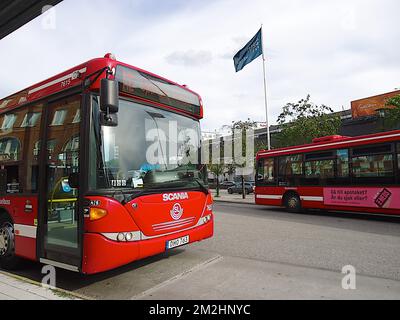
[82, 220, 214, 274]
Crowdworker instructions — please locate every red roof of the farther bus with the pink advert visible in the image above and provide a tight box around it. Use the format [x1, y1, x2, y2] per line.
[257, 130, 400, 158]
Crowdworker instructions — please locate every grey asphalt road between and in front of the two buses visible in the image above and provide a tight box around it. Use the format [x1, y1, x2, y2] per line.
[3, 203, 400, 299]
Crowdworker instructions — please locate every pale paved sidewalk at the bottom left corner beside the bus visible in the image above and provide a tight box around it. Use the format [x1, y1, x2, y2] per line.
[0, 271, 80, 300]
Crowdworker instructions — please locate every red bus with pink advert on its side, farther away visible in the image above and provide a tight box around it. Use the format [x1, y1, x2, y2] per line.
[255, 131, 400, 215]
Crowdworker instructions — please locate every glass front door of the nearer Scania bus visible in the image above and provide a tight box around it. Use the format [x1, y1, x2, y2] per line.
[40, 96, 81, 271]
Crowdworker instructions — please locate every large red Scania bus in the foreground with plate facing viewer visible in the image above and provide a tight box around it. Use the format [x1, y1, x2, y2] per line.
[0, 54, 213, 274]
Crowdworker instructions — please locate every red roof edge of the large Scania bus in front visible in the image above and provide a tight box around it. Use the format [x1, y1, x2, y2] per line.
[0, 54, 203, 118]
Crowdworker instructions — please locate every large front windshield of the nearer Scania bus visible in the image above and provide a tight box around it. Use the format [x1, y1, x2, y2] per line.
[89, 98, 207, 191]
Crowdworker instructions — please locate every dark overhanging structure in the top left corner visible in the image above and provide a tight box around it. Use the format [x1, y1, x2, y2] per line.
[0, 0, 62, 40]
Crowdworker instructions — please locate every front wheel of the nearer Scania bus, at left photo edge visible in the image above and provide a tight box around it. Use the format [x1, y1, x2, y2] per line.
[0, 213, 20, 270]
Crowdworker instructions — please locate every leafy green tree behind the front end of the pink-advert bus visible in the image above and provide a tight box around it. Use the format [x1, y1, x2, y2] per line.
[277, 95, 341, 147]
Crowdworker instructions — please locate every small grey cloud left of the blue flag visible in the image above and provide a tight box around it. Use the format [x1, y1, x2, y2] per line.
[165, 50, 213, 67]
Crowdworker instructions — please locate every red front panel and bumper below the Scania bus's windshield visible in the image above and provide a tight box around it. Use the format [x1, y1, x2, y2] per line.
[82, 192, 214, 274]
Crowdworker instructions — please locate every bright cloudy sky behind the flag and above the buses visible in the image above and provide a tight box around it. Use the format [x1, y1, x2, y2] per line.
[0, 0, 400, 132]
